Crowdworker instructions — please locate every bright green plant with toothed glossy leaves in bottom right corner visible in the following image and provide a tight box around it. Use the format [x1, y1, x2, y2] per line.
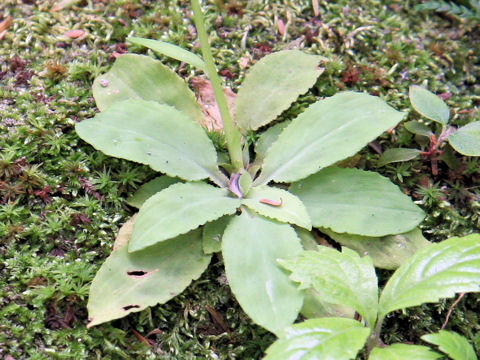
[265, 234, 480, 360]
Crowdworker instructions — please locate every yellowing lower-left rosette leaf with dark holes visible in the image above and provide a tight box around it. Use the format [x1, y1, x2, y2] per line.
[87, 230, 210, 327]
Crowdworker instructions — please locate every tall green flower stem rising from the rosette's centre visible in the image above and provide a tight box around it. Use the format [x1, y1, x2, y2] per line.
[191, 0, 243, 172]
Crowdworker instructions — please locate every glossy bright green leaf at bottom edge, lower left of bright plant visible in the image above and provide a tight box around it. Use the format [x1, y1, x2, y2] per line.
[264, 318, 370, 360]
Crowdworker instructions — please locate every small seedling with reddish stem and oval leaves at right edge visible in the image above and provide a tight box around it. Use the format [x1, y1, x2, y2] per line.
[378, 85, 480, 175]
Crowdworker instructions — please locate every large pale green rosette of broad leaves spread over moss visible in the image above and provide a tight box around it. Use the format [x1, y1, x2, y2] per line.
[76, 2, 428, 334]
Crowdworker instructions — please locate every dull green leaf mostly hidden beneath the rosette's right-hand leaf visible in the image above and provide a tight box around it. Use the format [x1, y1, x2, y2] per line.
[321, 228, 430, 270]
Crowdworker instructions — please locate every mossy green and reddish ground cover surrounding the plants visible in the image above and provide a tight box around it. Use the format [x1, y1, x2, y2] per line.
[0, 0, 480, 359]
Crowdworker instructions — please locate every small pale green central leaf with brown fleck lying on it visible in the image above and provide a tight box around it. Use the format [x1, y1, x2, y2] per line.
[242, 185, 312, 230]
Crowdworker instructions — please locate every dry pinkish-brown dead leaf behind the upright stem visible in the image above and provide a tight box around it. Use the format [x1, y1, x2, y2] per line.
[190, 76, 236, 131]
